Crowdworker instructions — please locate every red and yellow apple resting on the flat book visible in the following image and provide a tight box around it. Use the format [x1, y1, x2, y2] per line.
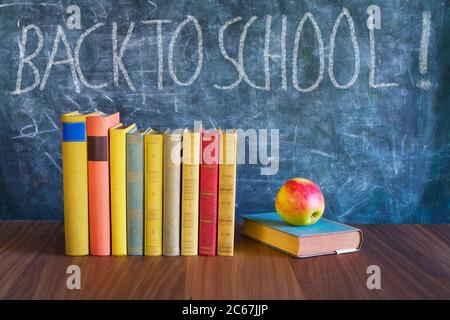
[275, 178, 325, 226]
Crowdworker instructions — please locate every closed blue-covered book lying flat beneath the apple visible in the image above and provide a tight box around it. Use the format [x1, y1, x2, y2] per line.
[243, 212, 363, 258]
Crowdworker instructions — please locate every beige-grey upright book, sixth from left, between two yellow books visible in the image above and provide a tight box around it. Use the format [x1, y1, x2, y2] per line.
[163, 134, 181, 256]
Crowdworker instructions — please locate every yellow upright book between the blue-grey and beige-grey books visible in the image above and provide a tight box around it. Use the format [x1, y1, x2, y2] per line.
[144, 130, 164, 256]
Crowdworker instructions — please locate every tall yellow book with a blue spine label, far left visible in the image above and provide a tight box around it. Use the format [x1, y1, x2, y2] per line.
[62, 117, 89, 256]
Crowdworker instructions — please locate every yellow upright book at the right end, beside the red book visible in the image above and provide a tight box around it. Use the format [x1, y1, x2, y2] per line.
[217, 130, 237, 256]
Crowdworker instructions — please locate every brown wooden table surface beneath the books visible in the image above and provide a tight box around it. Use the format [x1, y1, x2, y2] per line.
[0, 221, 450, 299]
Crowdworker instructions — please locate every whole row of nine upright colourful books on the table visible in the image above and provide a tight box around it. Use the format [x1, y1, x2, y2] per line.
[61, 112, 237, 256]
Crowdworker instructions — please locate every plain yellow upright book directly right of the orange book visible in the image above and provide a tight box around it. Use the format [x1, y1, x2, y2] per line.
[109, 124, 136, 256]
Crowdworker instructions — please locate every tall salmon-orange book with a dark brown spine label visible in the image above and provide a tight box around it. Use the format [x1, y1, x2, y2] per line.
[86, 112, 120, 256]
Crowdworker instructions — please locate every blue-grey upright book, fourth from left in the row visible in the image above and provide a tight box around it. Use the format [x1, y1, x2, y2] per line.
[127, 133, 144, 255]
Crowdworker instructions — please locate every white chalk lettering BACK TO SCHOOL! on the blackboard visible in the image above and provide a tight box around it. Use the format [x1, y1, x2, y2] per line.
[11, 5, 432, 95]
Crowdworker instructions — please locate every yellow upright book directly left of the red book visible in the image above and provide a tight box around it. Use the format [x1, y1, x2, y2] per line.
[181, 130, 200, 256]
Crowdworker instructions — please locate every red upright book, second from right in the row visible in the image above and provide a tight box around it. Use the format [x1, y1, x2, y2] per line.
[199, 130, 220, 256]
